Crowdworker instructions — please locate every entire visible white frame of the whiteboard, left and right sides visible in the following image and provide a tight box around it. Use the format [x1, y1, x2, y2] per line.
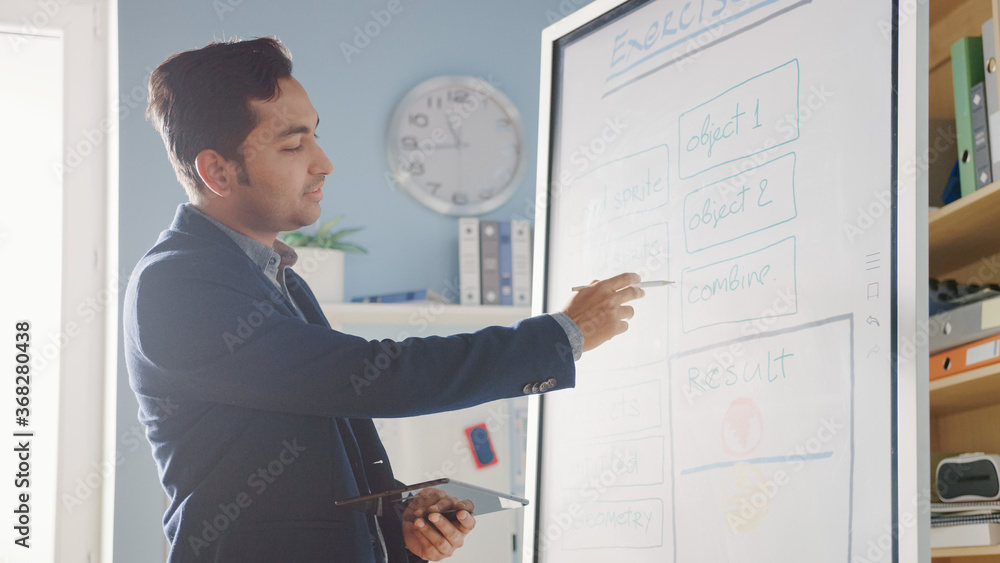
[521, 0, 930, 563]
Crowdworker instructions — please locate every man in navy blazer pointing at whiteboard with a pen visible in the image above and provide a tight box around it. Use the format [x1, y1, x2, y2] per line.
[124, 39, 642, 563]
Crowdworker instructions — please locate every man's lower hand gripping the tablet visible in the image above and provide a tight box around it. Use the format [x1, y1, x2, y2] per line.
[403, 488, 476, 561]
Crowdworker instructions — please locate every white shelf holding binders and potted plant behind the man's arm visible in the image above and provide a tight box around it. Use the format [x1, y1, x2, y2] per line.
[320, 301, 531, 326]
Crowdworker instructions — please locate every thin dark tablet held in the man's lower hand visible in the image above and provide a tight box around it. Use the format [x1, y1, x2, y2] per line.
[333, 477, 528, 516]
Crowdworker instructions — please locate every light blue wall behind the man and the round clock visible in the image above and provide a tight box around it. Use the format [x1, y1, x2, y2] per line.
[115, 0, 589, 563]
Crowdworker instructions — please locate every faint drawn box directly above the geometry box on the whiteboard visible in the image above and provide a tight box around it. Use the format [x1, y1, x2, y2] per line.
[561, 436, 666, 489]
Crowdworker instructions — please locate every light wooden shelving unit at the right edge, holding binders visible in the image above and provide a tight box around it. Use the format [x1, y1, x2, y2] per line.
[928, 0, 1000, 563]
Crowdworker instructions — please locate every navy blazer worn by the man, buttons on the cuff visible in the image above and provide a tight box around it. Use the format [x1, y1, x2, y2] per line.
[124, 205, 575, 563]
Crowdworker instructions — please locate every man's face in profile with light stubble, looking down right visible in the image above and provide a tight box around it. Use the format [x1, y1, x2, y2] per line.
[233, 78, 333, 233]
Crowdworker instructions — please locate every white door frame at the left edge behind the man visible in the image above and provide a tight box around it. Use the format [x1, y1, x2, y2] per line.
[0, 0, 117, 563]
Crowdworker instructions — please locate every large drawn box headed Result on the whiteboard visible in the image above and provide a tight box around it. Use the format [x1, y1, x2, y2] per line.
[668, 314, 854, 563]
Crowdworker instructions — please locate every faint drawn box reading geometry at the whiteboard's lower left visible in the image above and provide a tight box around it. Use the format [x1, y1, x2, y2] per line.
[563, 498, 664, 551]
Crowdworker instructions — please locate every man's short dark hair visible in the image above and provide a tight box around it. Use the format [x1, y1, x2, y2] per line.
[146, 37, 292, 200]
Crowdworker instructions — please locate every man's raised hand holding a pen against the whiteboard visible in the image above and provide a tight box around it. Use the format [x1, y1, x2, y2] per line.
[563, 273, 646, 352]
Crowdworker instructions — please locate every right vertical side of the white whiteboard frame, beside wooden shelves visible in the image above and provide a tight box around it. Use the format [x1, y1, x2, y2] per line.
[893, 0, 931, 563]
